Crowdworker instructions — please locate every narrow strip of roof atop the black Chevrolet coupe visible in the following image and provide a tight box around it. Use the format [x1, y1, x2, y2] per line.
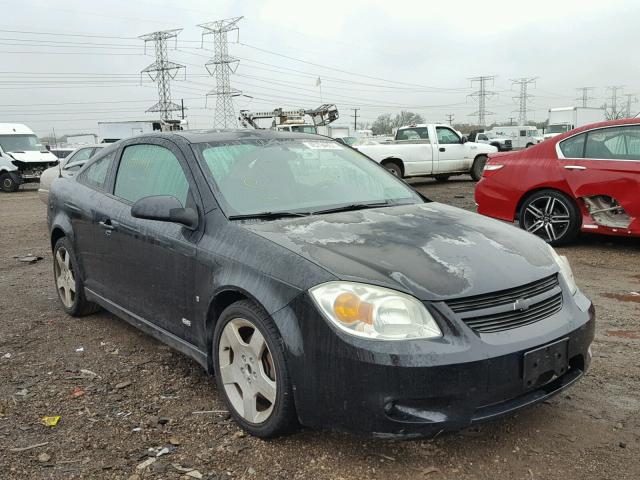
[157, 129, 320, 143]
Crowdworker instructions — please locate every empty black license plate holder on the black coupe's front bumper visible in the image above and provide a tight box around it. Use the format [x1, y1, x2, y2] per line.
[523, 338, 569, 389]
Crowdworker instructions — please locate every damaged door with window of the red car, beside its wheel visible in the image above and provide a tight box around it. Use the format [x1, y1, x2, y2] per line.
[557, 125, 640, 228]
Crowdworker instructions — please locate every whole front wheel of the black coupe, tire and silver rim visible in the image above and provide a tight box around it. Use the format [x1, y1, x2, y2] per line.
[212, 300, 298, 438]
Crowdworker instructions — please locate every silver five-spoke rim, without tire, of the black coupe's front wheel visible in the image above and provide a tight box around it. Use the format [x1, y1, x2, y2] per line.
[218, 318, 277, 424]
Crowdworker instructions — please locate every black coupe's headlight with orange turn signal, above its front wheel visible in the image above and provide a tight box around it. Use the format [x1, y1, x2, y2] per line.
[309, 282, 442, 340]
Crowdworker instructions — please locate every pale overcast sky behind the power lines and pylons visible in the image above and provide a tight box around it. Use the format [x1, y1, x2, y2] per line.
[0, 0, 640, 135]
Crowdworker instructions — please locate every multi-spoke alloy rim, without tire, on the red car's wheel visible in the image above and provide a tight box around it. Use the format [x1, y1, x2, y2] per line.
[523, 196, 571, 242]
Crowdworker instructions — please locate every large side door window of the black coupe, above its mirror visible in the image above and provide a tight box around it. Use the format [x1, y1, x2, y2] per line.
[113, 145, 189, 205]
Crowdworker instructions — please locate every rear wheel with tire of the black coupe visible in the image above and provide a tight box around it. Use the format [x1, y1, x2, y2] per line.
[53, 237, 100, 317]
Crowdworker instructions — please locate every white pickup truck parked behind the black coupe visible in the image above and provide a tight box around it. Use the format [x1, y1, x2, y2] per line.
[355, 124, 498, 182]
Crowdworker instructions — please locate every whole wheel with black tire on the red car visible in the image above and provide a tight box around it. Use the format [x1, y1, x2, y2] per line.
[518, 190, 581, 245]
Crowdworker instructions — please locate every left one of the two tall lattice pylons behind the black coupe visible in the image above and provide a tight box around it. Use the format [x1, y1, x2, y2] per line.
[139, 28, 185, 120]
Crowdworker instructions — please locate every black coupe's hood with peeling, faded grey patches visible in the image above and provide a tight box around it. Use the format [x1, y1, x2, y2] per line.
[242, 203, 558, 300]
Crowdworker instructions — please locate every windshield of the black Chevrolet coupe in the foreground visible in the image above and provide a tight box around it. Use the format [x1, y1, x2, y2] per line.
[194, 139, 423, 216]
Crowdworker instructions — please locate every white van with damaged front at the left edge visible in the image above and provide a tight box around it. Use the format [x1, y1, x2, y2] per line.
[0, 123, 58, 192]
